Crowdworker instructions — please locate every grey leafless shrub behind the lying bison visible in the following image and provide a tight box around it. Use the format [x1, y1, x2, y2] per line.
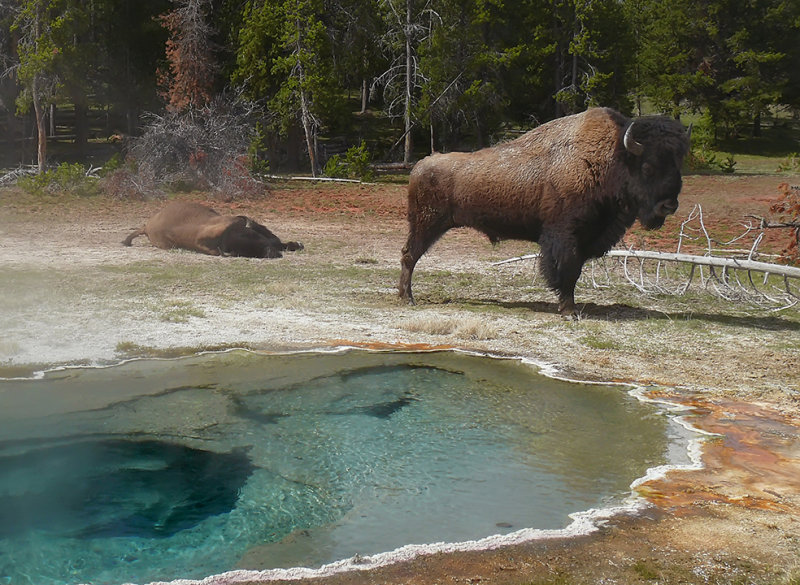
[118, 94, 263, 197]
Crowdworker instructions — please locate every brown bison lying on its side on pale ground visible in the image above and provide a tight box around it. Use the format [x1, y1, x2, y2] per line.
[122, 202, 303, 258]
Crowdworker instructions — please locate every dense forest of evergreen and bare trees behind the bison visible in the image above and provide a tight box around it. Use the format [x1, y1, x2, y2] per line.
[0, 0, 800, 182]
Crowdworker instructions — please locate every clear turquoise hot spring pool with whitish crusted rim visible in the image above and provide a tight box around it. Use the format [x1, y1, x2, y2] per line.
[0, 351, 689, 585]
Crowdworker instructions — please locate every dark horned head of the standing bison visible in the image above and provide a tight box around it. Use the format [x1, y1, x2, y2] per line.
[623, 116, 690, 230]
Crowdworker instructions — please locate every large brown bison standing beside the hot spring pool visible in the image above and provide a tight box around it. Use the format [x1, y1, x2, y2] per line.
[399, 108, 689, 318]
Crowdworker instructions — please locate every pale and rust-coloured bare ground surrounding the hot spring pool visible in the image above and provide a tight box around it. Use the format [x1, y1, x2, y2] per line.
[0, 176, 800, 584]
